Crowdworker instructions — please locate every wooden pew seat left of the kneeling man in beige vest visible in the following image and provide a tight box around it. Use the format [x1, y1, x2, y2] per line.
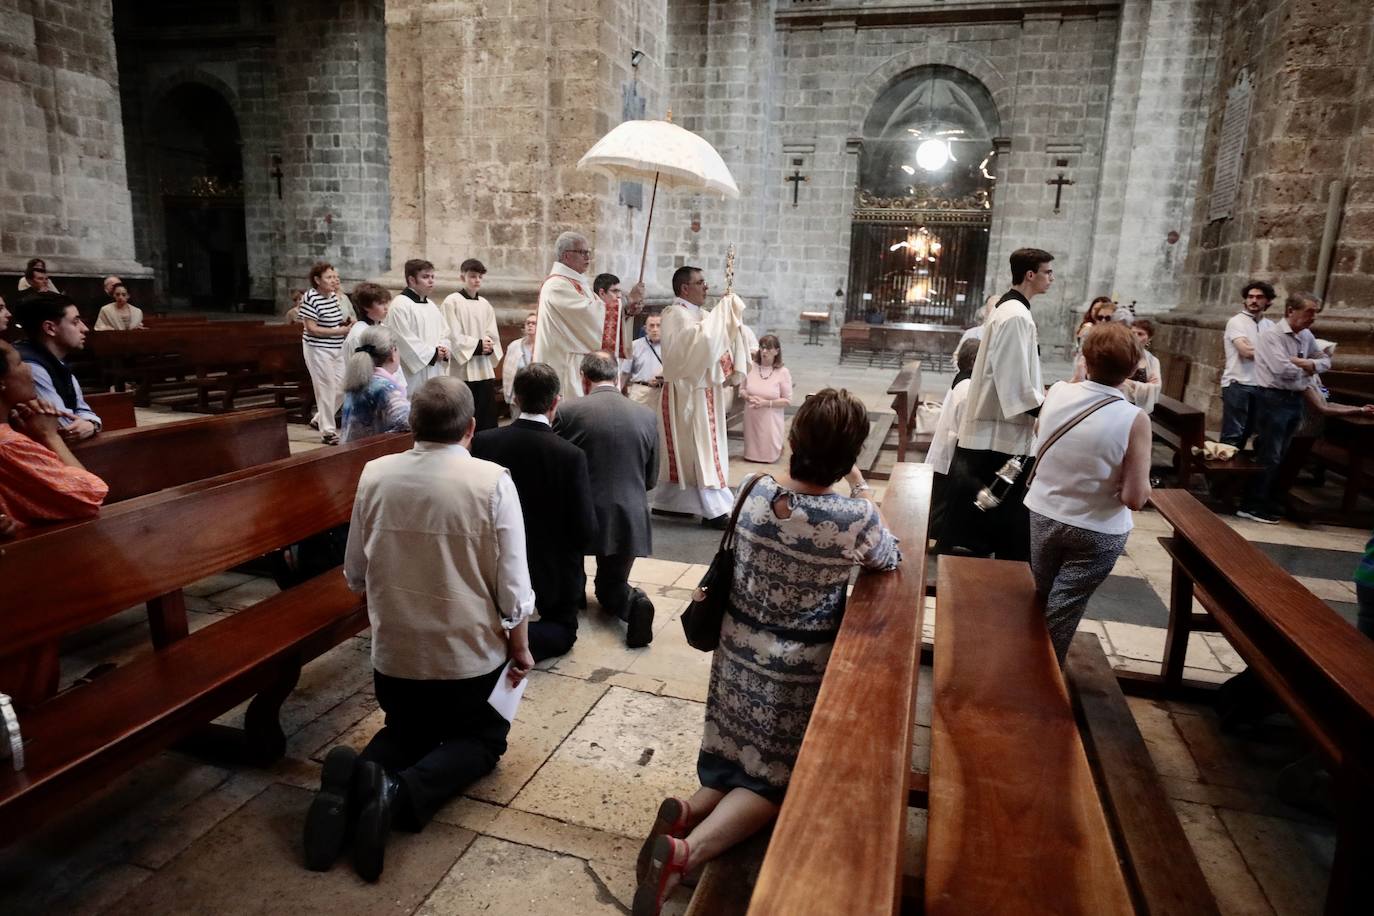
[0, 569, 367, 846]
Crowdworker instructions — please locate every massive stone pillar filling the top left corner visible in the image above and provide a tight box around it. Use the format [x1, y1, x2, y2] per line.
[0, 0, 148, 277]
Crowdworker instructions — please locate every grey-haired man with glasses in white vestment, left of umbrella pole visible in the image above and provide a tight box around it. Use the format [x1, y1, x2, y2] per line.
[534, 232, 644, 398]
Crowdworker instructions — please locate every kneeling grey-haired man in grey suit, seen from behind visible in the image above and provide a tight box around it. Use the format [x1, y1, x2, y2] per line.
[554, 350, 658, 648]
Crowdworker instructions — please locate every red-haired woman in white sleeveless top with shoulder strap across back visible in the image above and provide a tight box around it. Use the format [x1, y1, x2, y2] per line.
[1026, 323, 1150, 667]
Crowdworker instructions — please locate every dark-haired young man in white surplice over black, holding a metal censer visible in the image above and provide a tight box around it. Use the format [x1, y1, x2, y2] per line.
[938, 249, 1054, 560]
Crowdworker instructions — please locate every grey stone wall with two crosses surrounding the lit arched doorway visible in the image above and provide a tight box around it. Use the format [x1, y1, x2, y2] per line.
[655, 0, 1117, 340]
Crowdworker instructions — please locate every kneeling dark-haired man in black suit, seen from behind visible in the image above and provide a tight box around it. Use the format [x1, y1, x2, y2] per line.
[473, 363, 596, 662]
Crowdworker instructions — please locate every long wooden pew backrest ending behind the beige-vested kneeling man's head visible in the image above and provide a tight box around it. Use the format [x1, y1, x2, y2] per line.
[0, 433, 411, 656]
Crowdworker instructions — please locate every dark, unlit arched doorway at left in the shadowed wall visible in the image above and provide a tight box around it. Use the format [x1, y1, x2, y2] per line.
[148, 82, 249, 309]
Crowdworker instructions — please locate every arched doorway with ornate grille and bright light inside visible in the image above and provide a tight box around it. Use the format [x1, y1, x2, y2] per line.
[845, 65, 1000, 325]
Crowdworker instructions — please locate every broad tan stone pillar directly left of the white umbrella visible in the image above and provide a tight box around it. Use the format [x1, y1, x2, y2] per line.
[385, 0, 665, 308]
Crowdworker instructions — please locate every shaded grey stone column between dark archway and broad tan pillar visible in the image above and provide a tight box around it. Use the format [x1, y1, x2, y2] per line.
[273, 0, 390, 302]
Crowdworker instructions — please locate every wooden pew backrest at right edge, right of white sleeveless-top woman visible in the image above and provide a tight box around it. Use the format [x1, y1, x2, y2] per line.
[1150, 490, 1374, 761]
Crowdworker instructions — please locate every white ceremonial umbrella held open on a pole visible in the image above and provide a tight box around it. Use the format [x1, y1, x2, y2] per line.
[577, 111, 739, 282]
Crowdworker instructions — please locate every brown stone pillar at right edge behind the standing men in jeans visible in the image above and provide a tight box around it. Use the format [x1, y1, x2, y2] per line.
[1157, 0, 1374, 411]
